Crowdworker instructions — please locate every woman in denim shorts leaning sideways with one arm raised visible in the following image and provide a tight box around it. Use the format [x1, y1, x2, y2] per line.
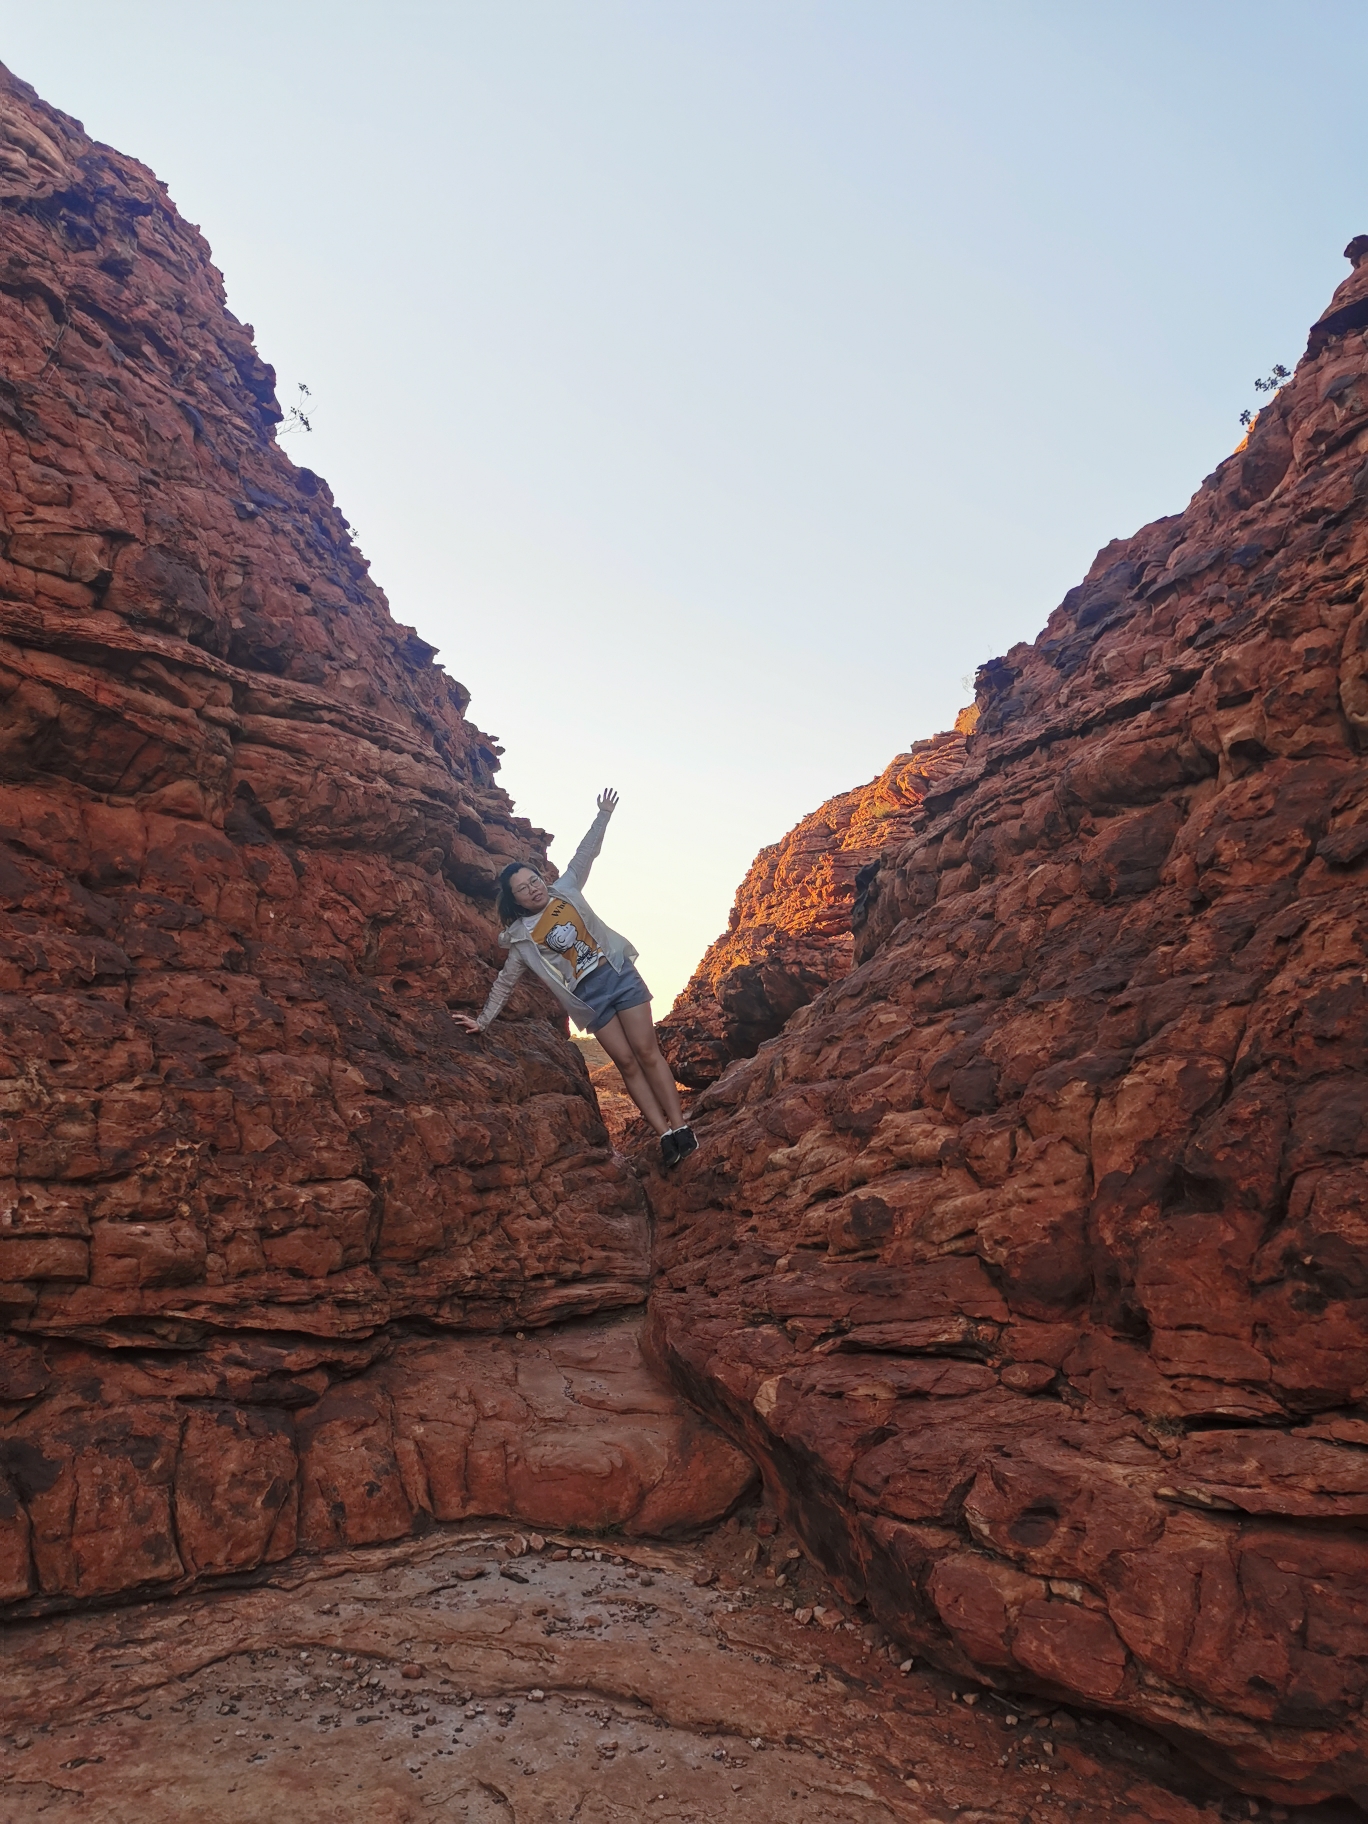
[454, 786, 699, 1171]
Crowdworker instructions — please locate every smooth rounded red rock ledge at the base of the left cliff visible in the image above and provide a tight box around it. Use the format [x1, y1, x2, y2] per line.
[0, 1315, 755, 1612]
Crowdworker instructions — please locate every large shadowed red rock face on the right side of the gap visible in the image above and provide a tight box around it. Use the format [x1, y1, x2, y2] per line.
[651, 243, 1368, 1798]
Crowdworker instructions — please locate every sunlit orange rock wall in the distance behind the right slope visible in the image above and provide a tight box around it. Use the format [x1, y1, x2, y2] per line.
[657, 725, 978, 1089]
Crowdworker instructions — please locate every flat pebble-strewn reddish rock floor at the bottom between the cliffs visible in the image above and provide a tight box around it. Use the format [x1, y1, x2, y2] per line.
[0, 1523, 1262, 1824]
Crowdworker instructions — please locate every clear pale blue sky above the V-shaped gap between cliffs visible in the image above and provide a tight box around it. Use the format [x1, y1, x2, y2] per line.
[0, 0, 1368, 1014]
